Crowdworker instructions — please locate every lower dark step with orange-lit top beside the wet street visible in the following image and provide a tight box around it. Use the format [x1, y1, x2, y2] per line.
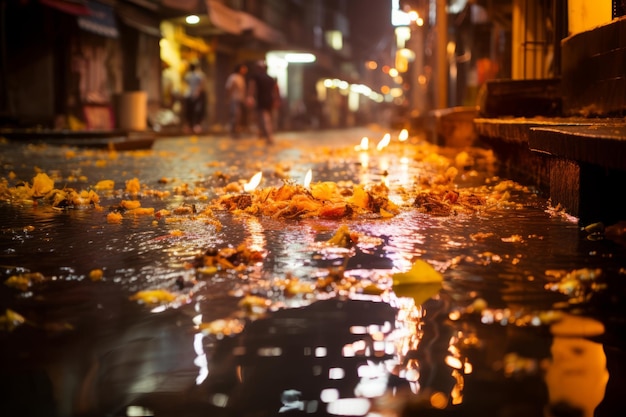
[475, 117, 626, 224]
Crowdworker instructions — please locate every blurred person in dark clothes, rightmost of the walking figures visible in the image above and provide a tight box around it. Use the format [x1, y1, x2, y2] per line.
[248, 61, 280, 145]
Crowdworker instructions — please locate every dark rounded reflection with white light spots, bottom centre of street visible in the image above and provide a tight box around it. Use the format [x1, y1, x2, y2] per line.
[202, 299, 402, 416]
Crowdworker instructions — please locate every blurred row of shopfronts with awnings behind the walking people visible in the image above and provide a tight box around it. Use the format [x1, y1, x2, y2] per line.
[0, 0, 394, 130]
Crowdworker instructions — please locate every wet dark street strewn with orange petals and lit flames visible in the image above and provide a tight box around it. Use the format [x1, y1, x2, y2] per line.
[0, 127, 626, 417]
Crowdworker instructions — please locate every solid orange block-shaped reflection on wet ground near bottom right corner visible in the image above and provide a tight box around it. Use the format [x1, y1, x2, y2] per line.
[546, 315, 609, 417]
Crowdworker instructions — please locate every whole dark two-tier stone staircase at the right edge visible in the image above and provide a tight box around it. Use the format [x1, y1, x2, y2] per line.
[474, 17, 626, 224]
